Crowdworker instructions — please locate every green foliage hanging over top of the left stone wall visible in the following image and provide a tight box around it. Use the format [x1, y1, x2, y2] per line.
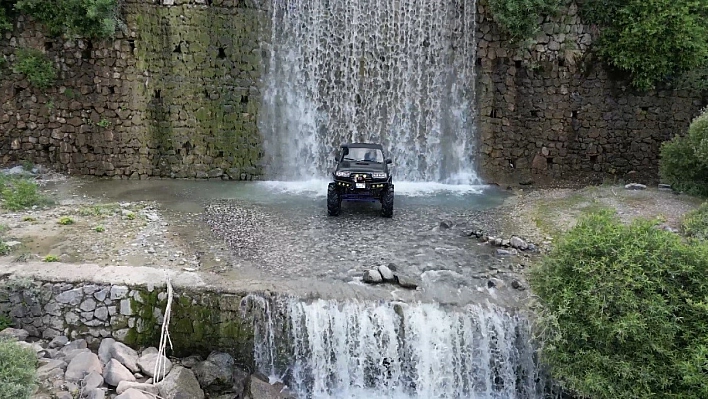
[15, 0, 118, 38]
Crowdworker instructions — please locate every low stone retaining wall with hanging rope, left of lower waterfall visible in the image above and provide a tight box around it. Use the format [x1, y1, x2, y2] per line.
[0, 278, 253, 369]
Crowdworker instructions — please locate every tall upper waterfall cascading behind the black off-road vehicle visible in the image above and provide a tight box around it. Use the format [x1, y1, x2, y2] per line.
[259, 0, 478, 184]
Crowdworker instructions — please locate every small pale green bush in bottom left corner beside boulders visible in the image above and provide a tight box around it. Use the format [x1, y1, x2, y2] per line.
[0, 338, 37, 399]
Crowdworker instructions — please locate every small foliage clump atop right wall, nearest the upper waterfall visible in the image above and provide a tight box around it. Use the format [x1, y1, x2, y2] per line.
[489, 0, 561, 41]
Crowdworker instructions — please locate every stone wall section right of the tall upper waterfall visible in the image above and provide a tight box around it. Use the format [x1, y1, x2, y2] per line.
[477, 1, 708, 183]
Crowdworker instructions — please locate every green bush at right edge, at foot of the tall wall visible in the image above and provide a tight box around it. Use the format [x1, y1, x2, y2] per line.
[659, 108, 708, 195]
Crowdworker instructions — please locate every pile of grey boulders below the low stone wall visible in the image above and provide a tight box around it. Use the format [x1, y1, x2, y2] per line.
[0, 328, 293, 399]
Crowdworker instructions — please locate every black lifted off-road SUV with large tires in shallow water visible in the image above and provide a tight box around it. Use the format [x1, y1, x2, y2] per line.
[327, 143, 393, 218]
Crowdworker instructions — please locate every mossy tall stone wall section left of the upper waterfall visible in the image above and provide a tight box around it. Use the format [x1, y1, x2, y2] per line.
[0, 0, 268, 180]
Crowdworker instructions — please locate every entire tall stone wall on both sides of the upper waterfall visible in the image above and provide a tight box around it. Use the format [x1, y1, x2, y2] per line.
[0, 0, 706, 183]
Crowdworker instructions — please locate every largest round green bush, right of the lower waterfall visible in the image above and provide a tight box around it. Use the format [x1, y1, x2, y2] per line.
[530, 211, 708, 399]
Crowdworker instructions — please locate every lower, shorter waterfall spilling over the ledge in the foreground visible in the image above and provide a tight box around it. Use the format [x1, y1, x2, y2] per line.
[242, 296, 546, 399]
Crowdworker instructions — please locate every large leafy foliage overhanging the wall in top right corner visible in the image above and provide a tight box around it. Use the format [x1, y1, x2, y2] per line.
[582, 0, 708, 90]
